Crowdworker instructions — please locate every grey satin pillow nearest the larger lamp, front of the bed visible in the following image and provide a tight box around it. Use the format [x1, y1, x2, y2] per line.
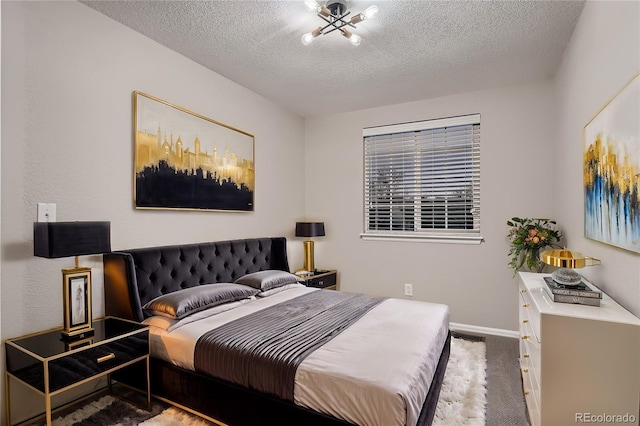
[142, 283, 258, 319]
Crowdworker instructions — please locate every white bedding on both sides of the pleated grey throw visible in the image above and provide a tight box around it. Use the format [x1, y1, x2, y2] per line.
[145, 286, 449, 426]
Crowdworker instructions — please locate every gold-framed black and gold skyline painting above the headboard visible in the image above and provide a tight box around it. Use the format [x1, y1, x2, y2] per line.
[133, 91, 255, 211]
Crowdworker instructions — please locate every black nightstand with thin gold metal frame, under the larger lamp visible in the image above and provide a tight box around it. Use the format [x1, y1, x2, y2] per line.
[5, 317, 151, 426]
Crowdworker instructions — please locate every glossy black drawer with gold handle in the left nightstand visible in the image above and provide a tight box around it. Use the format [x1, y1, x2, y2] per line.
[46, 330, 149, 392]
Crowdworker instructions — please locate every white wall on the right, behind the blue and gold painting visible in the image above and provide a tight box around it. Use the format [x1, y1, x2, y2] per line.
[554, 2, 640, 316]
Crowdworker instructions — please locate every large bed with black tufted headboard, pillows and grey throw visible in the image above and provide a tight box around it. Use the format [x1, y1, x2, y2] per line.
[104, 237, 451, 426]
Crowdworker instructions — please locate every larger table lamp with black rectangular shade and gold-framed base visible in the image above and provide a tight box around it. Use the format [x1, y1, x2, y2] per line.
[33, 222, 111, 340]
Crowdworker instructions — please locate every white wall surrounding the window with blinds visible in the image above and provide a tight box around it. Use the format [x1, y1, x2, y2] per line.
[305, 81, 555, 330]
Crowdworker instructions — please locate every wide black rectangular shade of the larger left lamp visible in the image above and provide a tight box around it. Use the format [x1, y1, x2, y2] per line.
[33, 222, 111, 259]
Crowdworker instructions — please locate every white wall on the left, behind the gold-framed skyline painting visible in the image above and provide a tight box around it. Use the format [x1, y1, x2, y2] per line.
[2, 2, 304, 338]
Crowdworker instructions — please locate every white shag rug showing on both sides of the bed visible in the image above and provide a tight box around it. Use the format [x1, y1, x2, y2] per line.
[52, 338, 487, 426]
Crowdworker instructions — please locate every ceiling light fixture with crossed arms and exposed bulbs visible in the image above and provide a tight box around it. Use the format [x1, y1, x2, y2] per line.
[302, 0, 378, 46]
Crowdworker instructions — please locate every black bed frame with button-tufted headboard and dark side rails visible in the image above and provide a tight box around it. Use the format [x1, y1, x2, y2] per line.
[104, 237, 451, 426]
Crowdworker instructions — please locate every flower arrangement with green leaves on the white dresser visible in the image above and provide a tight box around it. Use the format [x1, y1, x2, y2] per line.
[507, 217, 562, 276]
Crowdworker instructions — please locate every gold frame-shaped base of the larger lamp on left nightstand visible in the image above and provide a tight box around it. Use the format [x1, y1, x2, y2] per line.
[62, 267, 93, 339]
